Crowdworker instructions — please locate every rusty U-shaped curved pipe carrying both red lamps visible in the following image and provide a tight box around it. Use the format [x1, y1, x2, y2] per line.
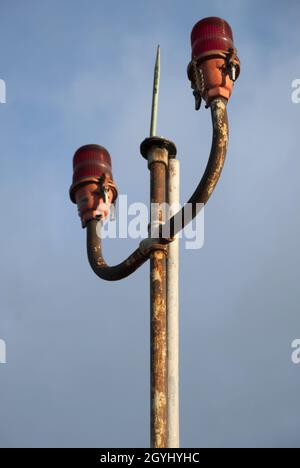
[87, 94, 228, 281]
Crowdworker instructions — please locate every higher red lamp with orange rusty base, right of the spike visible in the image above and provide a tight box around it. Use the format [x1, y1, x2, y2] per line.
[187, 17, 240, 110]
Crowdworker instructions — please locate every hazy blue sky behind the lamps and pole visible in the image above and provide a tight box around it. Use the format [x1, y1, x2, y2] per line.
[0, 0, 300, 447]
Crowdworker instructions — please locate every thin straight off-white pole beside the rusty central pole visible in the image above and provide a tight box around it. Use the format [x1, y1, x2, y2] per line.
[167, 158, 180, 448]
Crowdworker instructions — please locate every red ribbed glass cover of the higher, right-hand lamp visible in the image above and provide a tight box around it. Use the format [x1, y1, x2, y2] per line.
[191, 16, 234, 59]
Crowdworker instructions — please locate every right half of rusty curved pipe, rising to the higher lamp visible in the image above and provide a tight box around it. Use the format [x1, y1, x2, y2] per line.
[162, 98, 229, 237]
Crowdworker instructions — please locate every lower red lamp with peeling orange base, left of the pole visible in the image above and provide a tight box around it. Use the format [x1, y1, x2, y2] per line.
[70, 145, 118, 227]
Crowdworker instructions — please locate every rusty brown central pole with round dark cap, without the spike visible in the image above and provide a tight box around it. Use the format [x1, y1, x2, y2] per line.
[141, 136, 176, 448]
